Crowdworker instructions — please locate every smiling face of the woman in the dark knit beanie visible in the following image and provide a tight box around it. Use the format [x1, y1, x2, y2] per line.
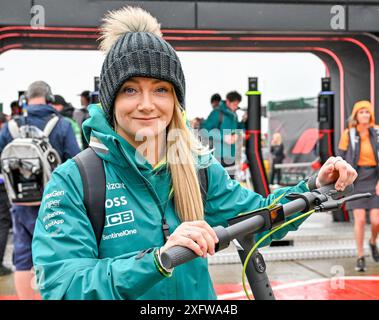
[114, 77, 175, 146]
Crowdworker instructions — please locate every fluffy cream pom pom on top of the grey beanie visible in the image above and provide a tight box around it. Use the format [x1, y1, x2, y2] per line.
[99, 6, 162, 52]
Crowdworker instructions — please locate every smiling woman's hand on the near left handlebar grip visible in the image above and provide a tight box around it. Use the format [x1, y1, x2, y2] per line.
[160, 220, 218, 258]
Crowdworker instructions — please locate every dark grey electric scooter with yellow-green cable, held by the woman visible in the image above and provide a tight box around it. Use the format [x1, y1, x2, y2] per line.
[161, 184, 371, 300]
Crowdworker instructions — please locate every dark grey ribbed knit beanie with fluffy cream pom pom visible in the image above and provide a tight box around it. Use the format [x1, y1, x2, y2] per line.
[99, 7, 185, 125]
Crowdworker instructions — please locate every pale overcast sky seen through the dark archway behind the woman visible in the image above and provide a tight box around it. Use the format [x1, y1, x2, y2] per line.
[0, 50, 325, 122]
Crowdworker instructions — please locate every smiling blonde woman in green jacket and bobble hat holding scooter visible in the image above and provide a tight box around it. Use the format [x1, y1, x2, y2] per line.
[33, 7, 356, 299]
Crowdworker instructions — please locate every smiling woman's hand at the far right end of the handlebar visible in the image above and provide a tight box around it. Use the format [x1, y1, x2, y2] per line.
[316, 157, 360, 191]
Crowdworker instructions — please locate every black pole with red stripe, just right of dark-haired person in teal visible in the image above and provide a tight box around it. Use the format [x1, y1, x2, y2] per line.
[245, 78, 270, 197]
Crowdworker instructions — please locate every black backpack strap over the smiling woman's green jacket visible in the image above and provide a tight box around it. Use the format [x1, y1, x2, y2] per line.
[73, 148, 105, 250]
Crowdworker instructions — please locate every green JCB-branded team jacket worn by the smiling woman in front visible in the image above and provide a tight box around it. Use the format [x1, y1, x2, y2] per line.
[32, 105, 309, 299]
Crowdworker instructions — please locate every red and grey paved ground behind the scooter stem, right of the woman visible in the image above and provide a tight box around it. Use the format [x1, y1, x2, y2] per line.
[209, 257, 379, 300]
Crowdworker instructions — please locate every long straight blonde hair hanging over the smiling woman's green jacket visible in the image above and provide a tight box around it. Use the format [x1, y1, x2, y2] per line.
[167, 91, 210, 221]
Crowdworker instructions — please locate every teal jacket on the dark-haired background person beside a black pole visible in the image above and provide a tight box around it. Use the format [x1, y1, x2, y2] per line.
[200, 101, 245, 164]
